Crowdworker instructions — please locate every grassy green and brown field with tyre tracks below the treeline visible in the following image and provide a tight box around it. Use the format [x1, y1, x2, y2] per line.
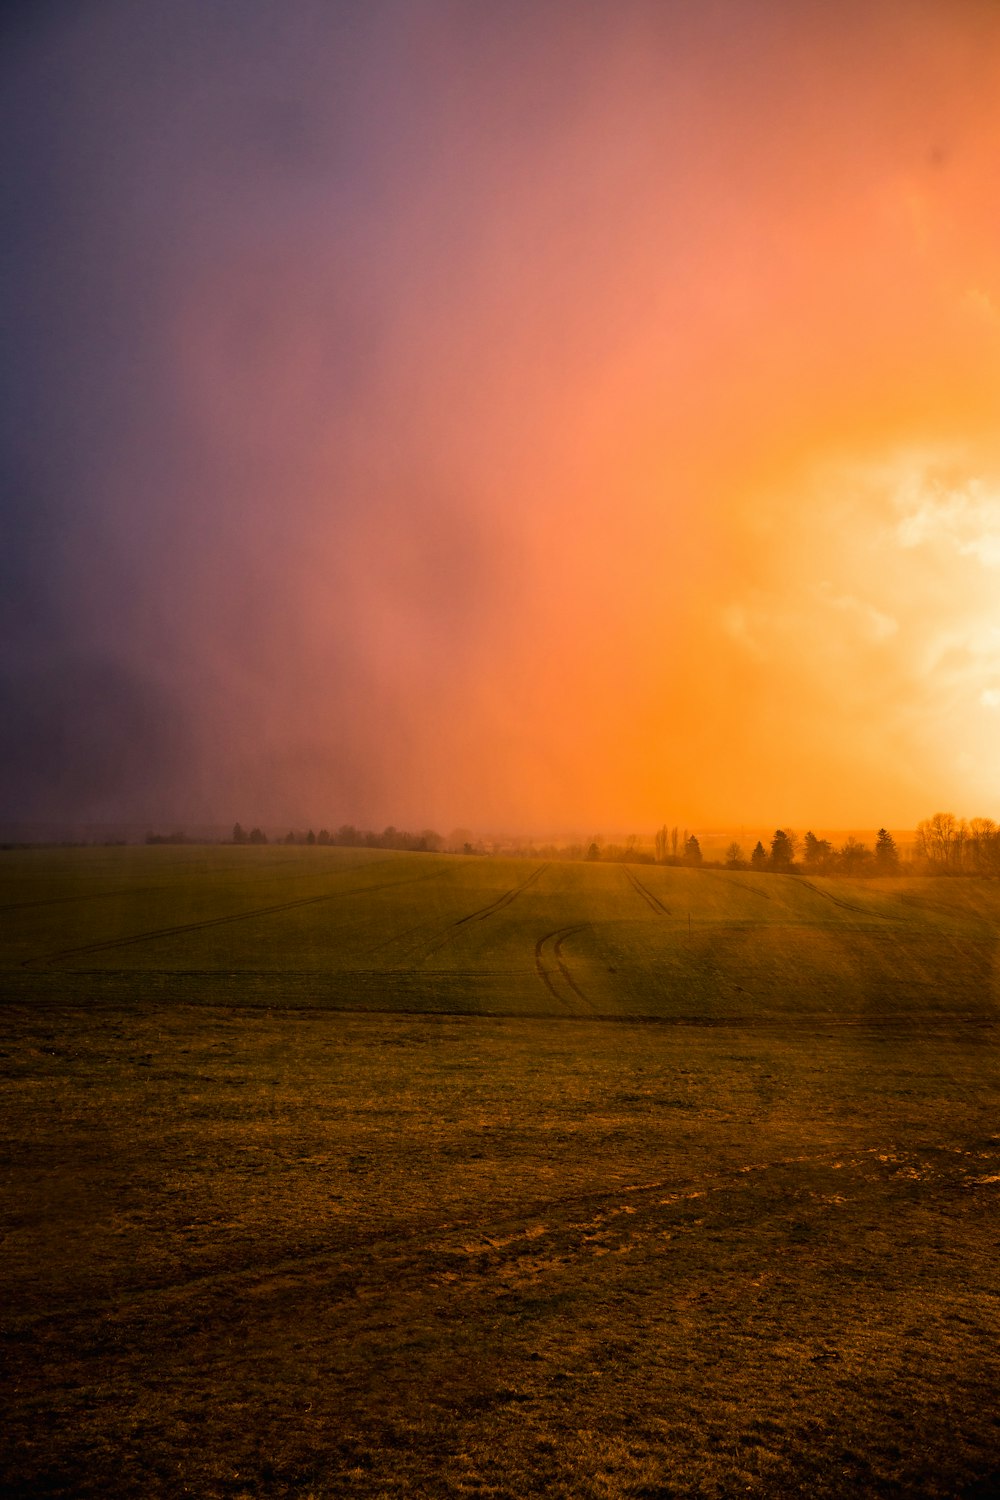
[0, 846, 1000, 1500]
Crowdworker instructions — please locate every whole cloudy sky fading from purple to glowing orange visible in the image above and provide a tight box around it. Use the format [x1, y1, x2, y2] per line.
[0, 0, 1000, 833]
